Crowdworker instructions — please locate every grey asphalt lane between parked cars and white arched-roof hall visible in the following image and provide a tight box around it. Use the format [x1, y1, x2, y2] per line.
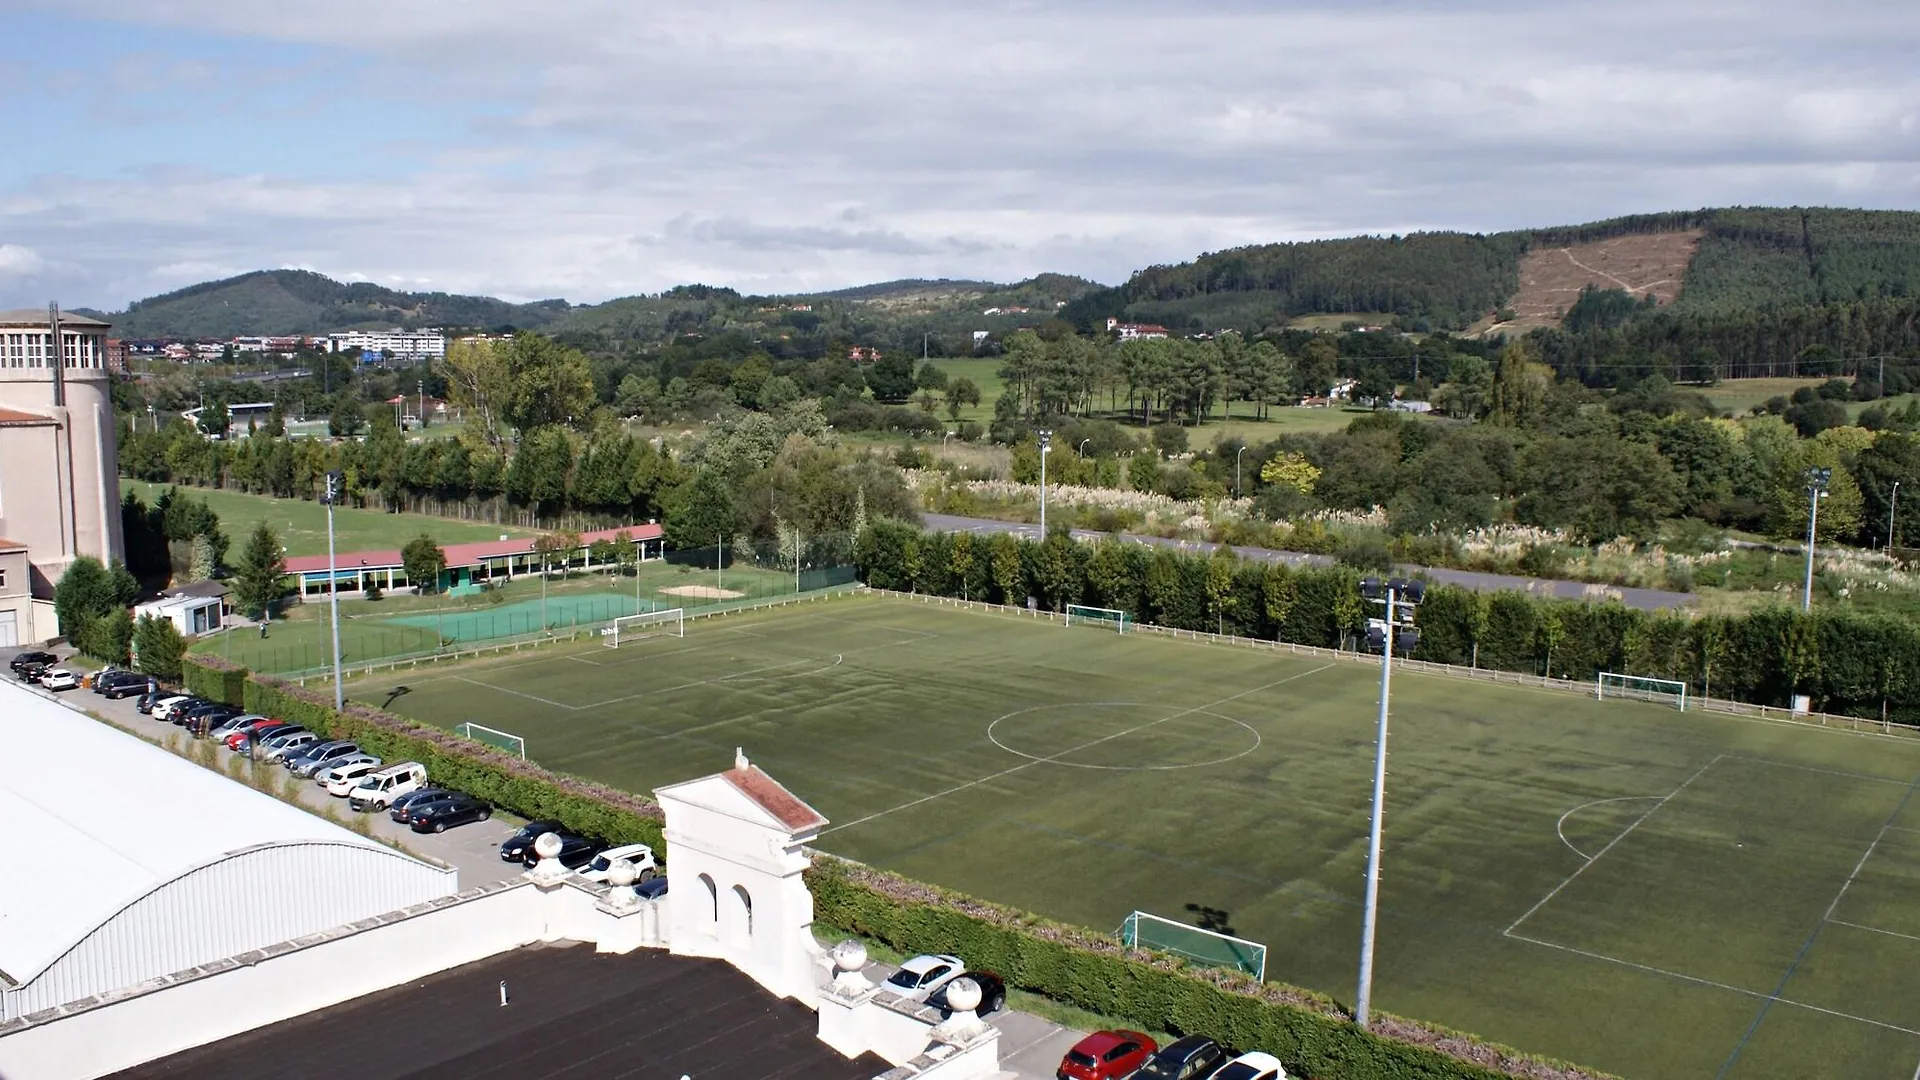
[0, 648, 524, 888]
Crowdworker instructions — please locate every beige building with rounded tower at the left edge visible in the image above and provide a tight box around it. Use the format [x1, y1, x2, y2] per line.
[0, 309, 125, 644]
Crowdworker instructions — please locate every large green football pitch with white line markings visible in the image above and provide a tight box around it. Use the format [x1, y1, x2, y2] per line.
[349, 596, 1920, 1080]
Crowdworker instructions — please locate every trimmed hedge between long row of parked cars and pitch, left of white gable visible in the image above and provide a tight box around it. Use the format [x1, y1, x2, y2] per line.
[182, 655, 666, 863]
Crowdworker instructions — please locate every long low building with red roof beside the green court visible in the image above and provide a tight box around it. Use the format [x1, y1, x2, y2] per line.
[286, 525, 662, 596]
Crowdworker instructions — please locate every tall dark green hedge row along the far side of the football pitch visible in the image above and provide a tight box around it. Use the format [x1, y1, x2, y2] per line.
[854, 521, 1920, 723]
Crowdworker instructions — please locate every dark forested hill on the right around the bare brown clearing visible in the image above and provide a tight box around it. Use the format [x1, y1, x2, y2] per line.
[1068, 208, 1920, 331]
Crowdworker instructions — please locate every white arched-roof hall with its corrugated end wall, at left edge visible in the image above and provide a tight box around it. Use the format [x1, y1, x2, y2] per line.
[0, 684, 459, 1022]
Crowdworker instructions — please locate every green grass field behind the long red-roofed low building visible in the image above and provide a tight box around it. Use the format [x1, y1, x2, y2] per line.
[121, 479, 536, 555]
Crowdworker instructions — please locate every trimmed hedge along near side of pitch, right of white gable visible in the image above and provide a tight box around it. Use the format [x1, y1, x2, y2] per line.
[806, 855, 1605, 1080]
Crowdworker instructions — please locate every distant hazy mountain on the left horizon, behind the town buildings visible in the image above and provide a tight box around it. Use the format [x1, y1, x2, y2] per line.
[98, 269, 570, 340]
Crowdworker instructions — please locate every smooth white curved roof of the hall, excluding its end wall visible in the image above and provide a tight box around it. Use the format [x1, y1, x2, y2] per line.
[0, 682, 412, 984]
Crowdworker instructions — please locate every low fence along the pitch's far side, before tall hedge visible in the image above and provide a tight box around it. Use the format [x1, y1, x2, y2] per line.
[868, 588, 1920, 736]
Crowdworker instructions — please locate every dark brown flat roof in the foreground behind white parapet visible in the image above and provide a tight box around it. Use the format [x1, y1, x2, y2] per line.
[115, 945, 887, 1080]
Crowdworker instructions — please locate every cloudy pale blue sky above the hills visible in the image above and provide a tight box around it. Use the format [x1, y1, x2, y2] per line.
[0, 0, 1920, 309]
